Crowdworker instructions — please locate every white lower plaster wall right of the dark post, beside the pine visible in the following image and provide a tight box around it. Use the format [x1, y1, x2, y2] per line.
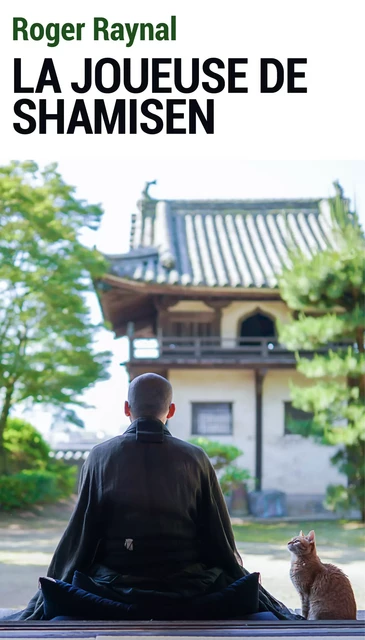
[262, 370, 343, 494]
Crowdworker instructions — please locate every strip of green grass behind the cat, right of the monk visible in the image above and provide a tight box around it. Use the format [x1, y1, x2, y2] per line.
[233, 520, 365, 550]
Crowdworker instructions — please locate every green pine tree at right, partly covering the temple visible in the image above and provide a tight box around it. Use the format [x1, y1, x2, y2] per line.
[278, 183, 365, 520]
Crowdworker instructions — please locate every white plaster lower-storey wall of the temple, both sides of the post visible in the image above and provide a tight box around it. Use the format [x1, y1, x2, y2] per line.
[169, 369, 343, 495]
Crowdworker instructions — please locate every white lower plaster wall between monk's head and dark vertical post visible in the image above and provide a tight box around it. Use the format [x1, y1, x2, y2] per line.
[169, 369, 255, 475]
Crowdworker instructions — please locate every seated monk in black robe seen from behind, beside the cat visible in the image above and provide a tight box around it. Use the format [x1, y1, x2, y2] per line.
[12, 373, 300, 620]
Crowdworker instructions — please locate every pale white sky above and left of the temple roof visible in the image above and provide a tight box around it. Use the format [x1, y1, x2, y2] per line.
[0, 159, 365, 435]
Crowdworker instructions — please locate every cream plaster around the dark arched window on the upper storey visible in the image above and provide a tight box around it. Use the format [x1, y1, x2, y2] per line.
[221, 300, 290, 338]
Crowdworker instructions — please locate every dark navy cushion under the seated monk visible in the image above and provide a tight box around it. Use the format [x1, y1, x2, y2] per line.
[40, 573, 260, 620]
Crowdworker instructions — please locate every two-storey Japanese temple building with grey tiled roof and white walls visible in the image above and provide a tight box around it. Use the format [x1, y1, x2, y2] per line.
[96, 189, 340, 512]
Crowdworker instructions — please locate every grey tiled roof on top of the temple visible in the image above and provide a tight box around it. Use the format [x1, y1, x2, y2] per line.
[106, 198, 333, 288]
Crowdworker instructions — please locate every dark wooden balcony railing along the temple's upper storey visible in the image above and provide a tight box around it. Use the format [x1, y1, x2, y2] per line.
[129, 336, 345, 363]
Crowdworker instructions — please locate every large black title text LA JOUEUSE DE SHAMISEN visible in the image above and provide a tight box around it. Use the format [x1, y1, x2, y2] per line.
[13, 58, 307, 135]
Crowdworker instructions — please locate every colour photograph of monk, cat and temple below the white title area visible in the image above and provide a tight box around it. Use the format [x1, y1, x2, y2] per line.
[0, 158, 365, 619]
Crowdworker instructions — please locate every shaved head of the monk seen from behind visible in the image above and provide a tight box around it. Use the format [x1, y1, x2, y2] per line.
[128, 373, 172, 419]
